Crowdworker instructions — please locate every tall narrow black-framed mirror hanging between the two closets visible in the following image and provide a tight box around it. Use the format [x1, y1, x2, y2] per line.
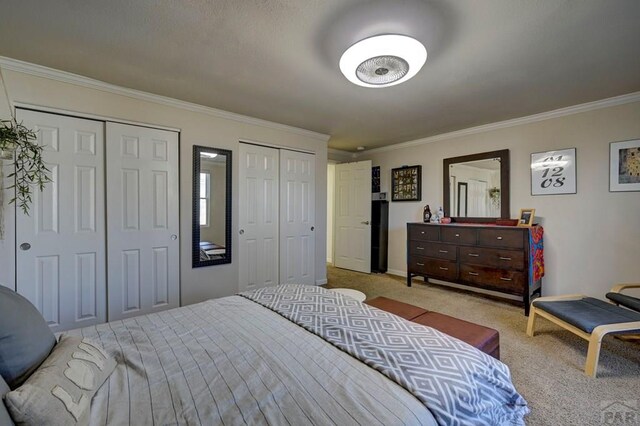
[191, 145, 231, 268]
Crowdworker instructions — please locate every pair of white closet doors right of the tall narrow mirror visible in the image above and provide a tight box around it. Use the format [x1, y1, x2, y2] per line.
[238, 143, 315, 291]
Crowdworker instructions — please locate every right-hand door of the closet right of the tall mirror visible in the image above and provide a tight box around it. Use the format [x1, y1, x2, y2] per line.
[280, 149, 316, 285]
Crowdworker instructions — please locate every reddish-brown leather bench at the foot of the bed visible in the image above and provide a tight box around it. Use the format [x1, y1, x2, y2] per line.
[366, 297, 500, 359]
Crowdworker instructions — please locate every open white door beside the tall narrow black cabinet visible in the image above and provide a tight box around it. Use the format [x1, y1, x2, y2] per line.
[333, 161, 371, 273]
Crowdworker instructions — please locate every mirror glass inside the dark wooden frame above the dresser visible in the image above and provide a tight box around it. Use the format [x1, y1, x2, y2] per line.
[449, 157, 501, 217]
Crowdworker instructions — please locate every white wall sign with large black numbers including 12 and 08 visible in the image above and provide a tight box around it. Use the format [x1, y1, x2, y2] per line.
[531, 148, 576, 195]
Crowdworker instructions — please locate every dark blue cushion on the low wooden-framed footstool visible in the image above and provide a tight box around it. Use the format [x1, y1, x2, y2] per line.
[533, 297, 640, 334]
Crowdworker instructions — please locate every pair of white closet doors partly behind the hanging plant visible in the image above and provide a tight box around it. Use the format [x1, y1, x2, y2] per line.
[16, 109, 179, 332]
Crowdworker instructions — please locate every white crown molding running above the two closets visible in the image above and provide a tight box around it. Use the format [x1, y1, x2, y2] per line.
[0, 56, 330, 142]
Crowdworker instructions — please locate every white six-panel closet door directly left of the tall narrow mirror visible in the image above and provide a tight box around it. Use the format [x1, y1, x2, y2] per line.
[107, 123, 180, 321]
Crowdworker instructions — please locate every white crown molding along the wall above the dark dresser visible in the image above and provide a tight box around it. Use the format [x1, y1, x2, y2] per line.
[354, 92, 640, 157]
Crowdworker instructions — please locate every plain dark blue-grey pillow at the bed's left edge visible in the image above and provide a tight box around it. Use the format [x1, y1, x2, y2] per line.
[0, 285, 56, 389]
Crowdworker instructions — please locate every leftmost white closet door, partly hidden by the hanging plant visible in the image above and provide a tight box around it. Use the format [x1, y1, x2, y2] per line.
[16, 109, 106, 332]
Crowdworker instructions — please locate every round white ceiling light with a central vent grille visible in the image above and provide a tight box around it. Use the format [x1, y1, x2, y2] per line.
[340, 34, 427, 88]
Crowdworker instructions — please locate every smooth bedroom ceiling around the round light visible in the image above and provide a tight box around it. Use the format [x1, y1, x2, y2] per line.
[0, 0, 640, 151]
